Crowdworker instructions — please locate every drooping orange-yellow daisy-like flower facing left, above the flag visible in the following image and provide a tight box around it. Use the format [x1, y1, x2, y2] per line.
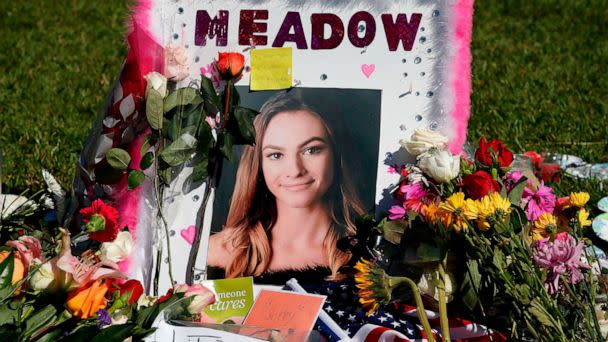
[355, 259, 391, 316]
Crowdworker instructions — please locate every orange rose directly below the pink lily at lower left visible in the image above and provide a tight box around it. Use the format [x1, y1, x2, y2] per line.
[65, 279, 109, 319]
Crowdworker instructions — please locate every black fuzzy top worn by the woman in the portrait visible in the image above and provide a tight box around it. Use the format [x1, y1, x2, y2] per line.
[207, 266, 331, 285]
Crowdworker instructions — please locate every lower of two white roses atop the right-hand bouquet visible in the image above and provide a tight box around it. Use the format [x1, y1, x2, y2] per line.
[418, 150, 460, 183]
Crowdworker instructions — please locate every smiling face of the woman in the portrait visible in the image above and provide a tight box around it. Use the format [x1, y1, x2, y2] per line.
[262, 110, 334, 208]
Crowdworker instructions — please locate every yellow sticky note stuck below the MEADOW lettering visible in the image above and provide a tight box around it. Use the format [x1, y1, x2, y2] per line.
[249, 47, 293, 90]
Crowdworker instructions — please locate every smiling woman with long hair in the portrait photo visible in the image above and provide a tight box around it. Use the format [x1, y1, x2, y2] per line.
[208, 91, 363, 283]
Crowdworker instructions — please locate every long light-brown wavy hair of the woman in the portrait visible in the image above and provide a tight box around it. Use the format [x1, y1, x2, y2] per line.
[226, 90, 363, 279]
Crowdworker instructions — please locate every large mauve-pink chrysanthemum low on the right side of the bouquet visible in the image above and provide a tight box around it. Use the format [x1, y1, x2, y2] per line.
[532, 235, 589, 294]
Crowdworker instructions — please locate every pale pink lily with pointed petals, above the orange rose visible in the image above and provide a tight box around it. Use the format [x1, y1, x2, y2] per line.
[51, 229, 125, 291]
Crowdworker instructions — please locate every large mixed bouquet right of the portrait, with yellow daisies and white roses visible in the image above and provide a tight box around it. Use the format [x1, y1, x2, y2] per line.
[355, 130, 603, 341]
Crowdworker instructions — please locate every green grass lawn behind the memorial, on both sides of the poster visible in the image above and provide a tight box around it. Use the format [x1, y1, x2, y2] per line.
[0, 0, 608, 203]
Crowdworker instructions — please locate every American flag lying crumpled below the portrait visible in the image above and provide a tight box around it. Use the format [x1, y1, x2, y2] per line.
[305, 281, 506, 342]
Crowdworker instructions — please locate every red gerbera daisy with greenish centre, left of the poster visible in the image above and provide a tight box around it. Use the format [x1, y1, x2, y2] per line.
[80, 199, 120, 242]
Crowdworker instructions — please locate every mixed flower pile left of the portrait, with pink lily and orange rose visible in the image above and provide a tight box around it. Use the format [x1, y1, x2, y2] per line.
[0, 180, 215, 341]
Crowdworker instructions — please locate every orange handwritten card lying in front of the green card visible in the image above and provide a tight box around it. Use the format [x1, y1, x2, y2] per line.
[244, 290, 325, 333]
